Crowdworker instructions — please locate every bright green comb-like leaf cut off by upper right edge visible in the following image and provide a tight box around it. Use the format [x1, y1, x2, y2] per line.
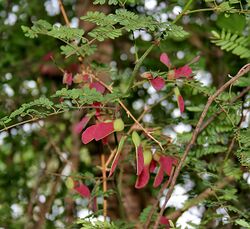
[211, 29, 250, 58]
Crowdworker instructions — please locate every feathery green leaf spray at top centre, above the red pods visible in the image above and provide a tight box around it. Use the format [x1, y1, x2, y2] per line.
[81, 9, 188, 41]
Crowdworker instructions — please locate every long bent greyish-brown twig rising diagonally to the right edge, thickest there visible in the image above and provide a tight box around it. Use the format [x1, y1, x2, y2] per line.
[154, 63, 250, 229]
